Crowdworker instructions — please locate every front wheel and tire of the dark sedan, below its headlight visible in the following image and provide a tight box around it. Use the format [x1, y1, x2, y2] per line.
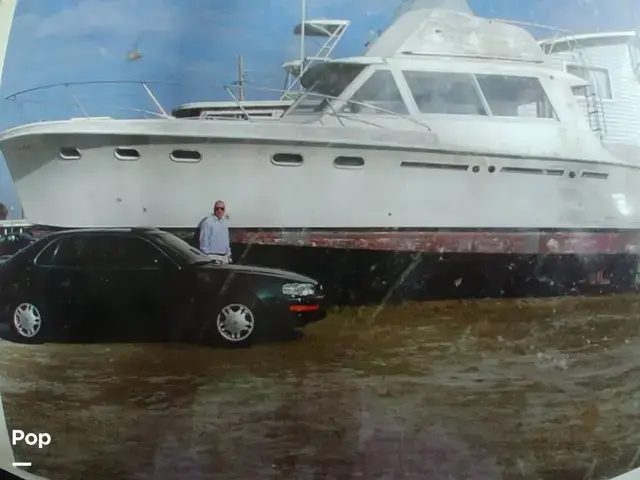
[207, 296, 262, 348]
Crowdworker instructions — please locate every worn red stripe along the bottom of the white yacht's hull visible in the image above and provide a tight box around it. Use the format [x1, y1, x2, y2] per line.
[231, 230, 640, 255]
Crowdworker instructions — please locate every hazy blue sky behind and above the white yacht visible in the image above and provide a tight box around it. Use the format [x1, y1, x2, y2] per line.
[0, 0, 640, 217]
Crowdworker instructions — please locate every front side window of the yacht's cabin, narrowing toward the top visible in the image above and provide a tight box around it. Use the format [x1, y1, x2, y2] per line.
[342, 70, 409, 115]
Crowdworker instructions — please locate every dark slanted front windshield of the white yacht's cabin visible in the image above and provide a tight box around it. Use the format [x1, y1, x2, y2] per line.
[286, 63, 368, 115]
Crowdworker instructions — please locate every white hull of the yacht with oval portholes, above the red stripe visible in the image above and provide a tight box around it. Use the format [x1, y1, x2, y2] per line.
[0, 120, 640, 230]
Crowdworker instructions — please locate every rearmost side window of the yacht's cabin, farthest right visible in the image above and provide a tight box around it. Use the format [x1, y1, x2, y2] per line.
[476, 74, 558, 120]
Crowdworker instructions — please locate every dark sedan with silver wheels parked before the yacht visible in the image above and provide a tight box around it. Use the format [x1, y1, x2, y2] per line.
[0, 228, 326, 346]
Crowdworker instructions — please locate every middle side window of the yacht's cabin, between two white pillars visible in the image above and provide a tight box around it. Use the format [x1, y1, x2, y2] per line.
[402, 71, 487, 115]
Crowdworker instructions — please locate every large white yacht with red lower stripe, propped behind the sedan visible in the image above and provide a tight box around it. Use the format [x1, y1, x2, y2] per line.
[0, 0, 640, 253]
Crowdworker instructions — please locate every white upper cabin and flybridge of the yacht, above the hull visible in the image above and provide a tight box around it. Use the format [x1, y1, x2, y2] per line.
[282, 9, 624, 163]
